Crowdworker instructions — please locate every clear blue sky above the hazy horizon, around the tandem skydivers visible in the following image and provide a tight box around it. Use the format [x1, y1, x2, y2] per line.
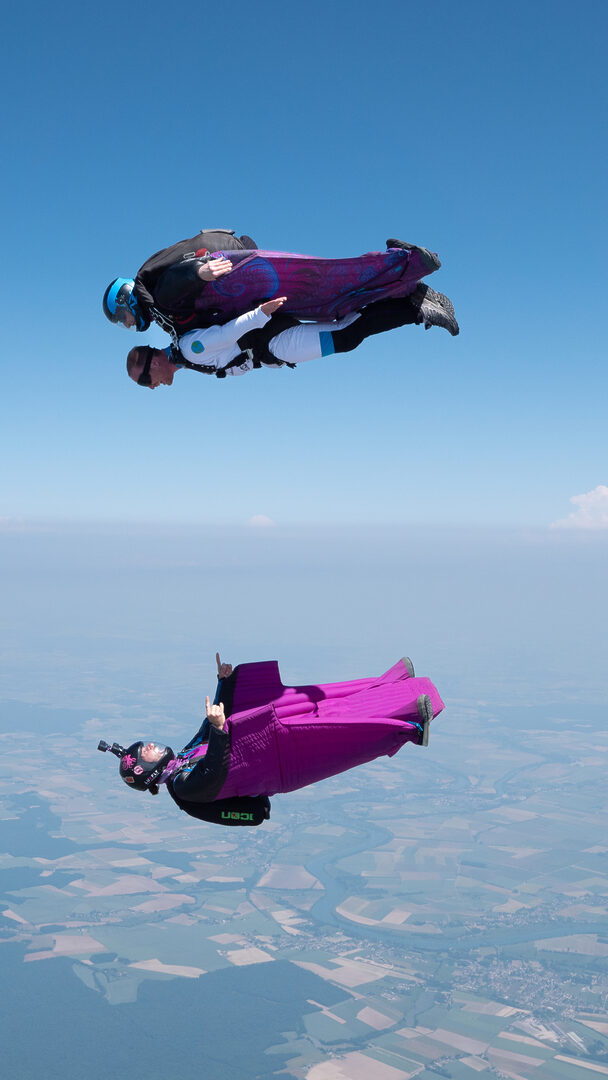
[0, 0, 608, 528]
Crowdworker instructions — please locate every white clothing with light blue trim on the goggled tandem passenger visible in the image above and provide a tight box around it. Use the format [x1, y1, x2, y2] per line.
[179, 307, 359, 375]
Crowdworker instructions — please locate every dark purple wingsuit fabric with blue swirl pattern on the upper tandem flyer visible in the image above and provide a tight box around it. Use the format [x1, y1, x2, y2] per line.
[194, 247, 438, 325]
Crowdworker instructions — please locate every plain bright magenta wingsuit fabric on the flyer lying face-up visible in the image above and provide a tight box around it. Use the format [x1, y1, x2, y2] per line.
[211, 660, 444, 799]
